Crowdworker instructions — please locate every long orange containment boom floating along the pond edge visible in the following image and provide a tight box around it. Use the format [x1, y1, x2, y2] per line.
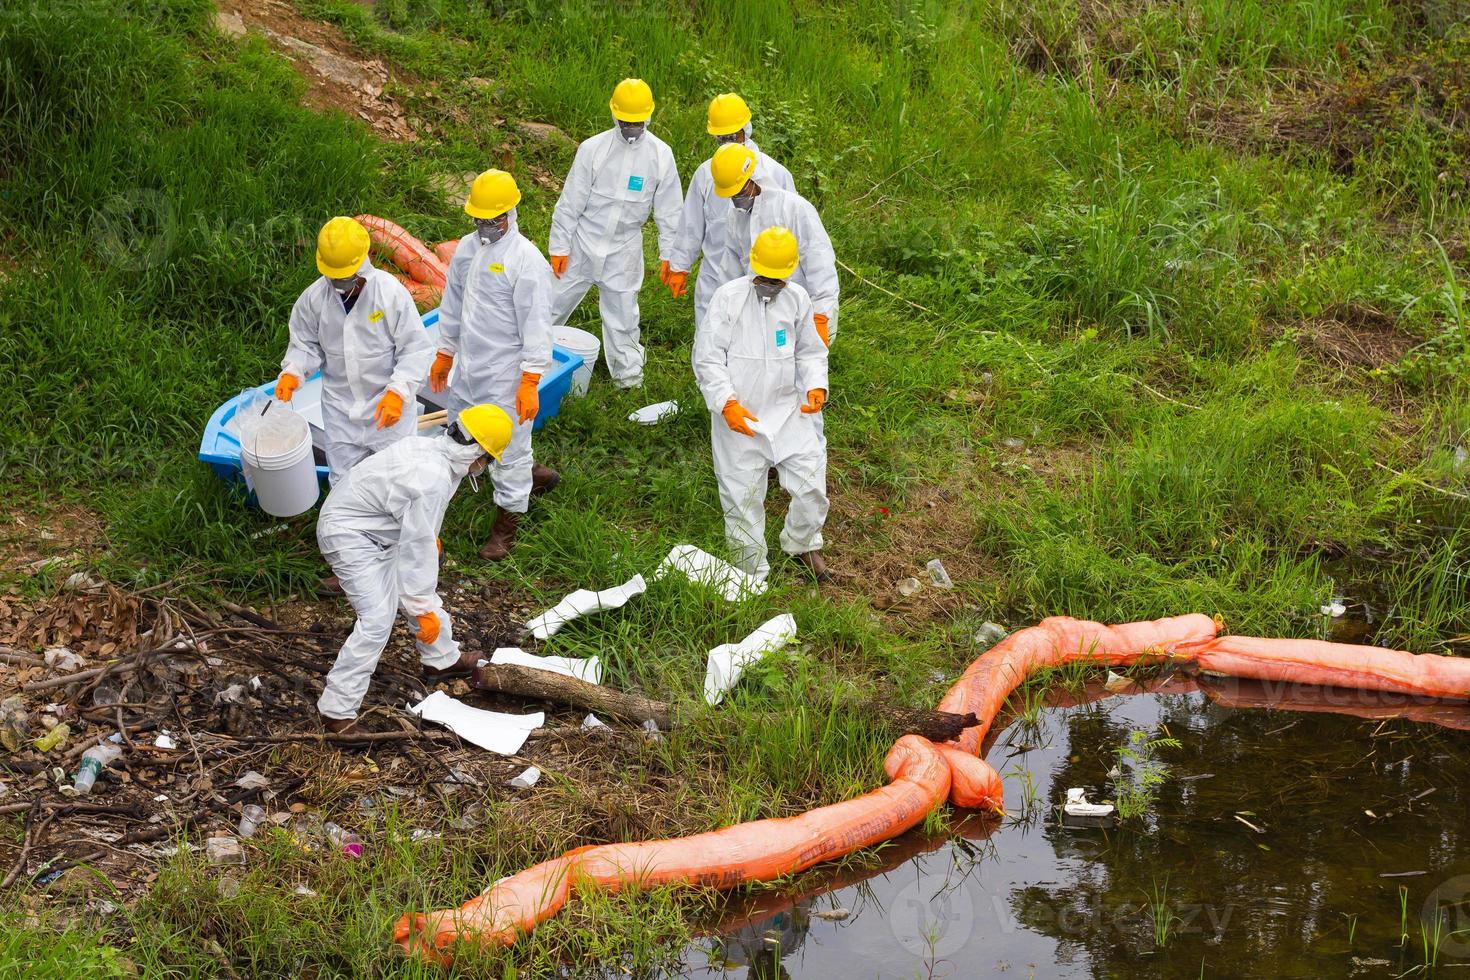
[394, 614, 1470, 962]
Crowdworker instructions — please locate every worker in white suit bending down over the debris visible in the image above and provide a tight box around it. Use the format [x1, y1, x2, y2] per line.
[316, 406, 512, 733]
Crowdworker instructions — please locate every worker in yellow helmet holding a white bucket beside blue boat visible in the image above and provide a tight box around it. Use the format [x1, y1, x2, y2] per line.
[275, 217, 434, 485]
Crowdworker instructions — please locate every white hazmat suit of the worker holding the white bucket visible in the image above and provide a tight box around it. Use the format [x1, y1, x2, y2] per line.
[281, 259, 434, 485]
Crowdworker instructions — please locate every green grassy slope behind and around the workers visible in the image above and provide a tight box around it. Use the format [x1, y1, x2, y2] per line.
[0, 0, 1470, 973]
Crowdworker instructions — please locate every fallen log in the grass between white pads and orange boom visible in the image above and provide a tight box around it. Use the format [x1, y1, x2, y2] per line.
[475, 664, 979, 742]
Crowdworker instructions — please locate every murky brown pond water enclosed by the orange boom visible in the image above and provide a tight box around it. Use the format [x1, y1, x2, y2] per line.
[684, 676, 1470, 980]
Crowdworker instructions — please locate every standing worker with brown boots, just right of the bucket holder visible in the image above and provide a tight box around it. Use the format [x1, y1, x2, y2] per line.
[429, 170, 562, 561]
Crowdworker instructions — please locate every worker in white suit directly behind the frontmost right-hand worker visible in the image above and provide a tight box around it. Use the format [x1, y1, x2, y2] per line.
[676, 143, 838, 345]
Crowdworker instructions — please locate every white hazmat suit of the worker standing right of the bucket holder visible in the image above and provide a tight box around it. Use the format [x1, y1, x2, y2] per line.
[440, 210, 551, 514]
